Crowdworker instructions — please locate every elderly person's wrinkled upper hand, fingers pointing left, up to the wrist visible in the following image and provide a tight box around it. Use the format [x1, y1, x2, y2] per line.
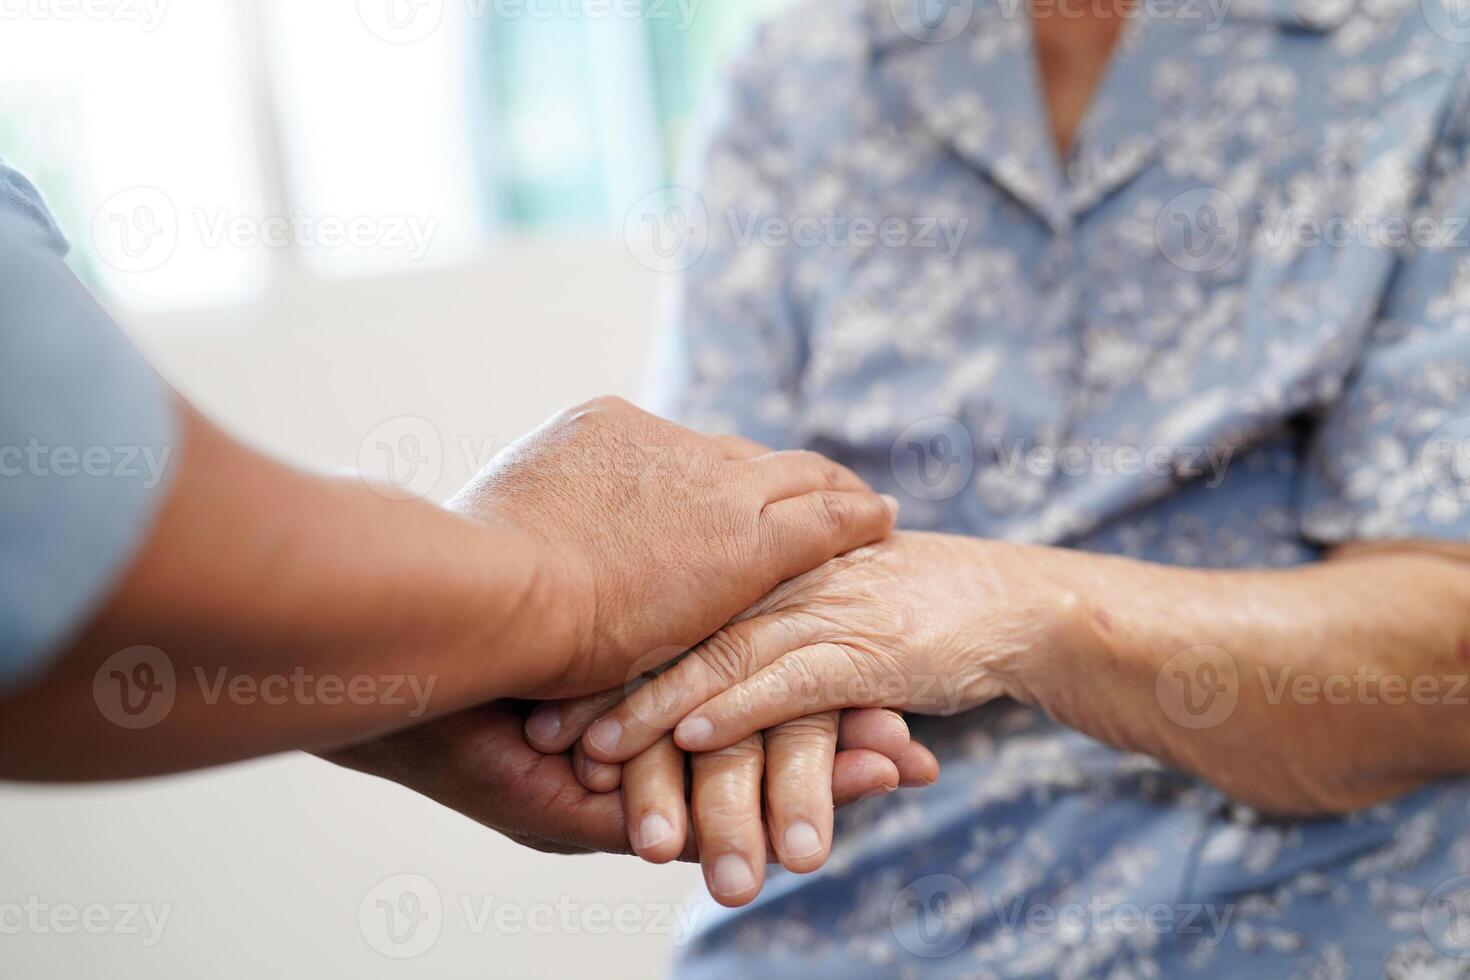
[570, 533, 1073, 763]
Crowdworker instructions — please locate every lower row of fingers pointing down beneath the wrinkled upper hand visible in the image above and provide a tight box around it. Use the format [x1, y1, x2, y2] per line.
[526, 705, 939, 907]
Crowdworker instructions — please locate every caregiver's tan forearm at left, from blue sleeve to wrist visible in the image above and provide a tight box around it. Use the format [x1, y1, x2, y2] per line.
[0, 407, 570, 779]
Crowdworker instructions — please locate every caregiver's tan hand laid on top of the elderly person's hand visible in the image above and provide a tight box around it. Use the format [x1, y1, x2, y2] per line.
[448, 398, 897, 698]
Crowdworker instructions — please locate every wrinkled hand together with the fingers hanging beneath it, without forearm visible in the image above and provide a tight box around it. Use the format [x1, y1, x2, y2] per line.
[525, 533, 1045, 907]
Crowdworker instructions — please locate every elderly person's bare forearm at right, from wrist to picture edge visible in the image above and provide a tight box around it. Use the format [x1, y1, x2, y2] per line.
[1005, 545, 1470, 814]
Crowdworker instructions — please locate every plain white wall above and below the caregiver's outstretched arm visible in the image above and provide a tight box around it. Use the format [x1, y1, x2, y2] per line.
[0, 242, 698, 980]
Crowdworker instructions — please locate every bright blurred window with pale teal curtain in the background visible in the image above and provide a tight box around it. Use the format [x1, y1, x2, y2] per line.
[0, 0, 789, 309]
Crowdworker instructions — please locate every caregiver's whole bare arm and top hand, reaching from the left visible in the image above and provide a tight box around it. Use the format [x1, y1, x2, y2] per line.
[0, 396, 894, 780]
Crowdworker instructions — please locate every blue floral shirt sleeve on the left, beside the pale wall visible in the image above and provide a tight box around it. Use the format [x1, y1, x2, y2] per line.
[645, 34, 804, 448]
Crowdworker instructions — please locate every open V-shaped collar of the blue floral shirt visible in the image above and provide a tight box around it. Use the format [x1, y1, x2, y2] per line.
[866, 0, 1357, 231]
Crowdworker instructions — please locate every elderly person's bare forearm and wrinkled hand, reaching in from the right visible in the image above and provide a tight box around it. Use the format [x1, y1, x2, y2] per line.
[570, 533, 1470, 815]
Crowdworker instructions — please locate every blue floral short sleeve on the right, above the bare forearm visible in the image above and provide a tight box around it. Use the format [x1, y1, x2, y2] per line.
[1298, 96, 1470, 545]
